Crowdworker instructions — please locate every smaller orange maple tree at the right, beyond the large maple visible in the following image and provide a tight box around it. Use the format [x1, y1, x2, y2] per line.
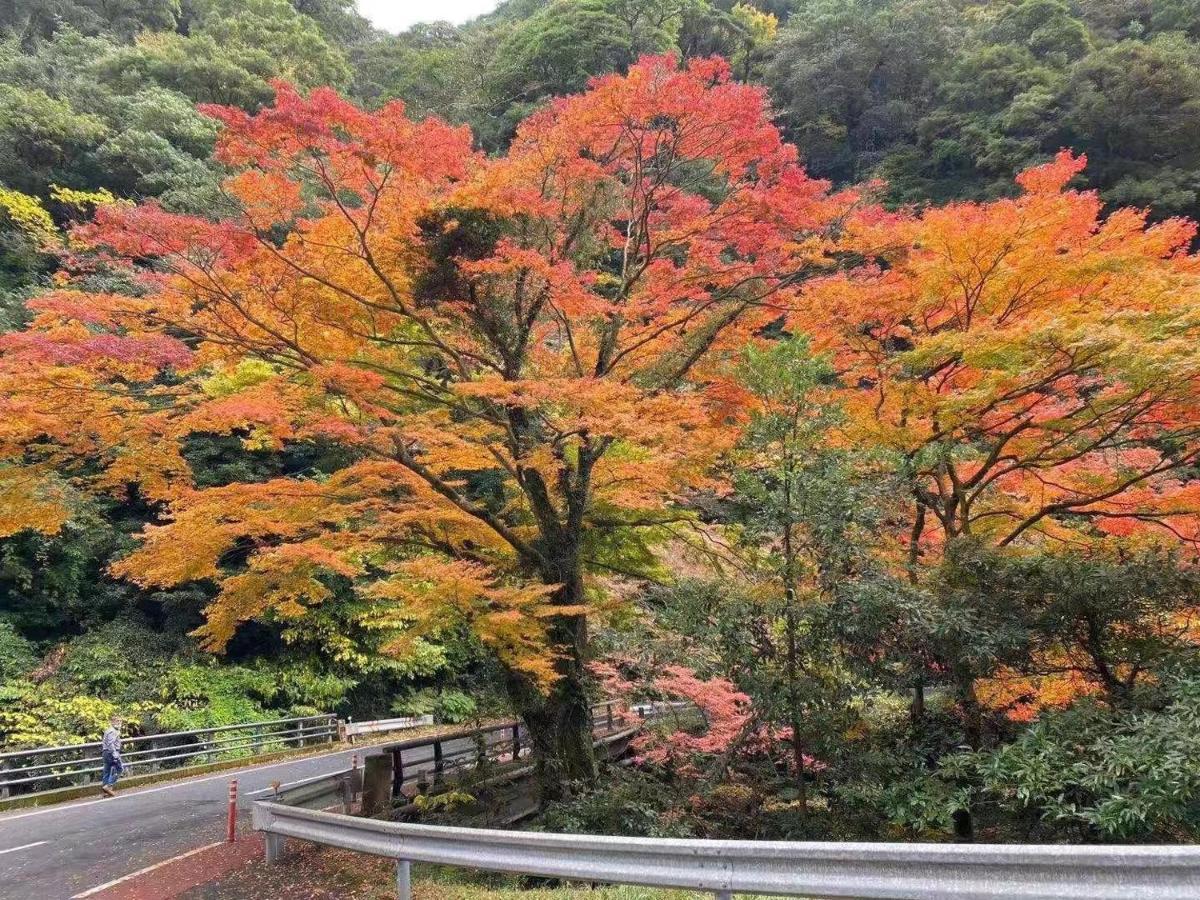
[794, 151, 1200, 708]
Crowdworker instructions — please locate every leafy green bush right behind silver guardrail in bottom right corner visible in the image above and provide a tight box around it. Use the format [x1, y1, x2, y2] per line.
[875, 677, 1200, 841]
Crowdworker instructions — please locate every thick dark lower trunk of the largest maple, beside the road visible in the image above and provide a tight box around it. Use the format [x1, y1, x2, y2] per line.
[508, 578, 596, 802]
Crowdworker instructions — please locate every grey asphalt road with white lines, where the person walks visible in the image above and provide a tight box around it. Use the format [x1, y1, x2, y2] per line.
[0, 740, 492, 900]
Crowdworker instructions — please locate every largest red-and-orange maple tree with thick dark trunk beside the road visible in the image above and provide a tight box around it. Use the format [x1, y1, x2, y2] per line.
[0, 58, 856, 786]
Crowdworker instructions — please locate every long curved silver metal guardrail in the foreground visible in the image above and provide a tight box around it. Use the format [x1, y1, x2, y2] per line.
[253, 800, 1200, 900]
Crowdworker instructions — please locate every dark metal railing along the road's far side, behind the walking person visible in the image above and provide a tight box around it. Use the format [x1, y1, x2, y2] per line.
[0, 715, 337, 796]
